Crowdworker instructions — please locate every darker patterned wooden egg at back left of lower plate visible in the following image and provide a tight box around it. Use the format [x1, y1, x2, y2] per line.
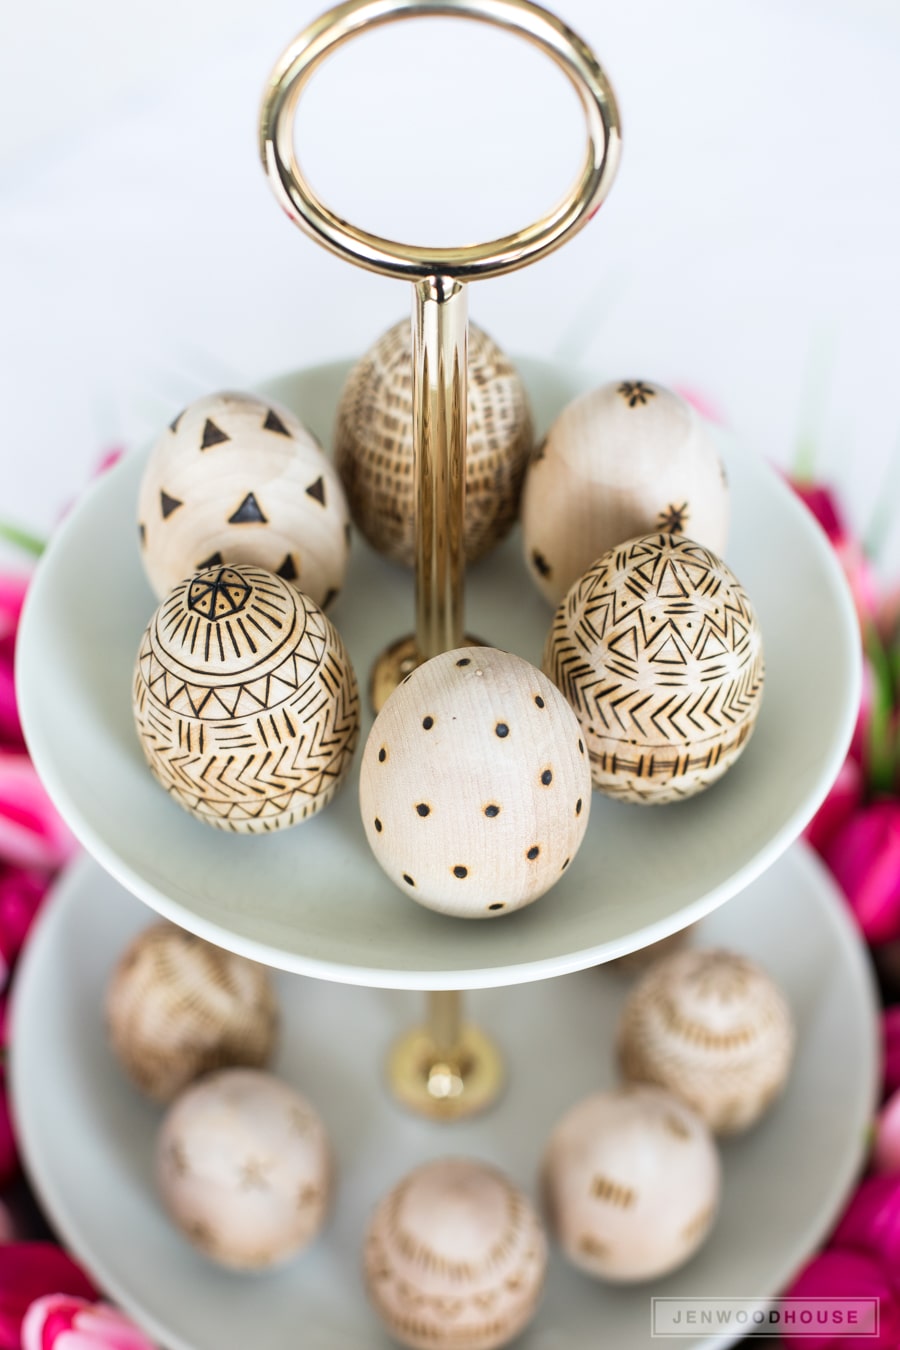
[107, 923, 278, 1102]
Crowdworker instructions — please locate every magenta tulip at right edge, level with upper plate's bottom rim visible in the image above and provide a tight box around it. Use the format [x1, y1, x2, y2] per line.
[823, 799, 900, 942]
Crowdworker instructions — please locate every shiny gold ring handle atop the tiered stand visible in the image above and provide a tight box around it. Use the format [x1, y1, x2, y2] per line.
[259, 0, 621, 281]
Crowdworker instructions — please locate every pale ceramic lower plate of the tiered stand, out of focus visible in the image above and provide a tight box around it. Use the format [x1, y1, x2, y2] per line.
[12, 845, 878, 1350]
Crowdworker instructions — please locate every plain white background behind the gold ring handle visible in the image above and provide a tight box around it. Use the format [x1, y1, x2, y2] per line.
[0, 0, 900, 571]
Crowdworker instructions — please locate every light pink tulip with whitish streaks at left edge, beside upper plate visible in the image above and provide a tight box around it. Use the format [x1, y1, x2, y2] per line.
[0, 751, 76, 872]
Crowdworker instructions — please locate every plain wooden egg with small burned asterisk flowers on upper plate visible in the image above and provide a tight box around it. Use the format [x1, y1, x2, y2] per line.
[522, 379, 729, 605]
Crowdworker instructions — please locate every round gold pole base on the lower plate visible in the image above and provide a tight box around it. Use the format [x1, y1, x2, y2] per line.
[387, 1026, 503, 1121]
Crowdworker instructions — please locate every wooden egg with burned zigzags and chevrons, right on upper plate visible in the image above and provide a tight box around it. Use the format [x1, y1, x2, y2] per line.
[544, 535, 764, 805]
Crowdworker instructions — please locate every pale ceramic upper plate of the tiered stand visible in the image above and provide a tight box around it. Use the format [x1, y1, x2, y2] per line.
[19, 362, 860, 988]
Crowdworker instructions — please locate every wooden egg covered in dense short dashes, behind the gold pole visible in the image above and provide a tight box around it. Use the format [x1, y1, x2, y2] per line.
[335, 321, 533, 567]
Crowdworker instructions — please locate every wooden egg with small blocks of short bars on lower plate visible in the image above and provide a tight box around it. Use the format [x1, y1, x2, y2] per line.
[542, 1087, 721, 1284]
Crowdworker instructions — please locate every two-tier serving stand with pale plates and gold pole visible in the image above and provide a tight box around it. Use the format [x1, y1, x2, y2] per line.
[12, 0, 877, 1350]
